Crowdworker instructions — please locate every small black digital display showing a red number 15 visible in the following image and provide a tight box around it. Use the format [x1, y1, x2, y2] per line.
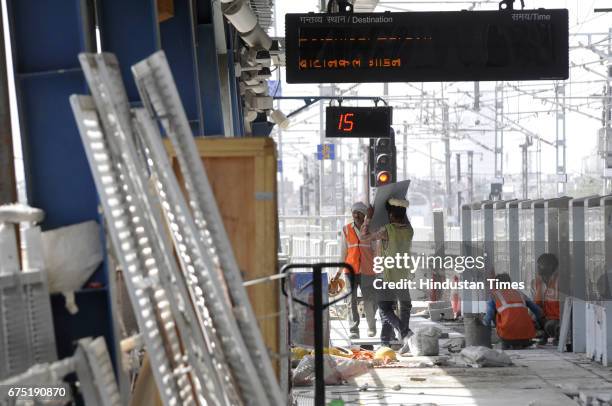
[325, 106, 393, 138]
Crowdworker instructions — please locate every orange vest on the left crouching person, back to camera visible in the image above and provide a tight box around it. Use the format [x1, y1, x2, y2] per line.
[493, 289, 536, 340]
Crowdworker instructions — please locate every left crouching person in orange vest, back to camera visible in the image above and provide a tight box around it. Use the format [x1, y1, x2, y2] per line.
[483, 273, 542, 350]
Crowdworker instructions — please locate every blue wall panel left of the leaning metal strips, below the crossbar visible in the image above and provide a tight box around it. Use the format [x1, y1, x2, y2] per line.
[19, 71, 98, 229]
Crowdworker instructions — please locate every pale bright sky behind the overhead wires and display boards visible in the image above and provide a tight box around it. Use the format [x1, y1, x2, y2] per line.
[270, 0, 612, 198]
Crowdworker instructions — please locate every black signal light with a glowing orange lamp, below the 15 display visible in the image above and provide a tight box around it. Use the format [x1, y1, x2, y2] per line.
[369, 128, 397, 187]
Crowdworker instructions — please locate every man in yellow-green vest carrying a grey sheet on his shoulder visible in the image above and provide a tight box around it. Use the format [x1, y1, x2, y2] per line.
[362, 198, 414, 354]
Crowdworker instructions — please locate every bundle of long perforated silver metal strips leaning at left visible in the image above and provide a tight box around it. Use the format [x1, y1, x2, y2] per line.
[70, 52, 282, 405]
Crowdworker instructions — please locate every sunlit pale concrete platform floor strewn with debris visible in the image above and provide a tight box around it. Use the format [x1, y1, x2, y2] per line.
[293, 317, 612, 406]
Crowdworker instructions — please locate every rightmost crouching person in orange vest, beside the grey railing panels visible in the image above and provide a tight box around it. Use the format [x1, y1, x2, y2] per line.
[535, 253, 561, 345]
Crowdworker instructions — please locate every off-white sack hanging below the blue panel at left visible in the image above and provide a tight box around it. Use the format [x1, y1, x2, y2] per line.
[42, 221, 103, 314]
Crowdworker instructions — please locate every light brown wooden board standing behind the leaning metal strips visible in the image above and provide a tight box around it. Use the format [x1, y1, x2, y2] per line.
[166, 137, 281, 373]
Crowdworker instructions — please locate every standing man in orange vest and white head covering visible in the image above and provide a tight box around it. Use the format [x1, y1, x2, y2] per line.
[333, 202, 377, 339]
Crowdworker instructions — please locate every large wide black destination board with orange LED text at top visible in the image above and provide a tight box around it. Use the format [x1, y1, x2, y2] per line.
[285, 9, 569, 83]
